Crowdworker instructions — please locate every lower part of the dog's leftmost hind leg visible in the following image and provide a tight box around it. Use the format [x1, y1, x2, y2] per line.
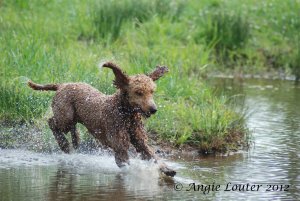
[48, 117, 70, 153]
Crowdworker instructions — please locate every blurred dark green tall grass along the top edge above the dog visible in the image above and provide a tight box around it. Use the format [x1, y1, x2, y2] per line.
[92, 0, 183, 42]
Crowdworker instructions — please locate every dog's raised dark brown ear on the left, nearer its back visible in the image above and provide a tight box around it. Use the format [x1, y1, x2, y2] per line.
[102, 62, 129, 89]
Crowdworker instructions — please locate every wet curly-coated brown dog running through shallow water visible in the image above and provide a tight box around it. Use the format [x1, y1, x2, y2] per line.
[28, 62, 176, 176]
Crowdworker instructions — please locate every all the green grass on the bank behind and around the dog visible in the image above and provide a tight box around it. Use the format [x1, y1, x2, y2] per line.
[0, 0, 300, 154]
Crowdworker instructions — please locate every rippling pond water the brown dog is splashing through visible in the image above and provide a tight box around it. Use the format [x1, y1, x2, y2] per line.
[0, 79, 300, 201]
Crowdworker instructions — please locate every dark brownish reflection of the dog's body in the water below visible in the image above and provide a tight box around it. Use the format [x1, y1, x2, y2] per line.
[47, 167, 127, 201]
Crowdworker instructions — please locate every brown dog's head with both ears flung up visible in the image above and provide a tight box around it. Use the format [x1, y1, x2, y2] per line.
[102, 62, 169, 117]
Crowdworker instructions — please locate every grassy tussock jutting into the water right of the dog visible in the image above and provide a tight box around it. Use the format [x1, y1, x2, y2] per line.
[148, 83, 246, 151]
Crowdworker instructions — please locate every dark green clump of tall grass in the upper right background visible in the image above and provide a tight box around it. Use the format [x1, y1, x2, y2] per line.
[195, 11, 250, 62]
